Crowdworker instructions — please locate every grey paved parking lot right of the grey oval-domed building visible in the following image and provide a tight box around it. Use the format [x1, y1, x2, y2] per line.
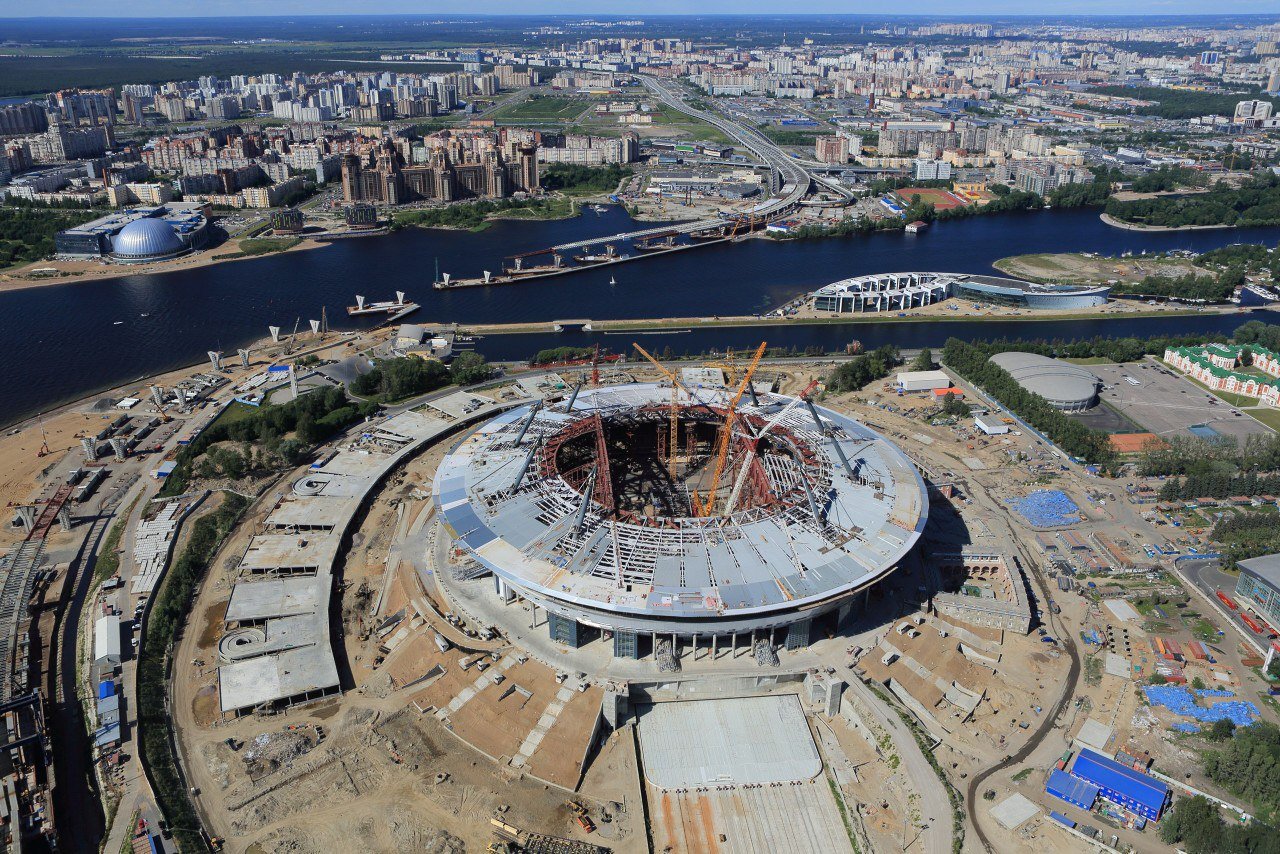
[1088, 360, 1271, 439]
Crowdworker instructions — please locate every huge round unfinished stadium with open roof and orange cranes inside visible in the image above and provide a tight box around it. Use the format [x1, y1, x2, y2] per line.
[433, 374, 928, 658]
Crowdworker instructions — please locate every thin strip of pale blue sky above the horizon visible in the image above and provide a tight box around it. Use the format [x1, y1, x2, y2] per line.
[10, 0, 1280, 18]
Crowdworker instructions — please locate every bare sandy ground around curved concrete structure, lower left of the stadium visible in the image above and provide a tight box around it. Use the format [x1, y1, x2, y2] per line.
[174, 437, 644, 854]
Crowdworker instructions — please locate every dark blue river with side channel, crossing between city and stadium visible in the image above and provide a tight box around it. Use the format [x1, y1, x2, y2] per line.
[0, 207, 1280, 424]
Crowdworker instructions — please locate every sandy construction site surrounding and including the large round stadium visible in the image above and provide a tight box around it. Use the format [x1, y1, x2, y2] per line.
[140, 327, 1280, 854]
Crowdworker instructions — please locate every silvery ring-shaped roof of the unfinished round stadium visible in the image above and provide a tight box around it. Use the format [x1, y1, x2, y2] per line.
[434, 384, 928, 617]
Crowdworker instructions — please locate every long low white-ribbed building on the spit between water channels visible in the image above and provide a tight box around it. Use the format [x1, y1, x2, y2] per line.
[813, 273, 1111, 314]
